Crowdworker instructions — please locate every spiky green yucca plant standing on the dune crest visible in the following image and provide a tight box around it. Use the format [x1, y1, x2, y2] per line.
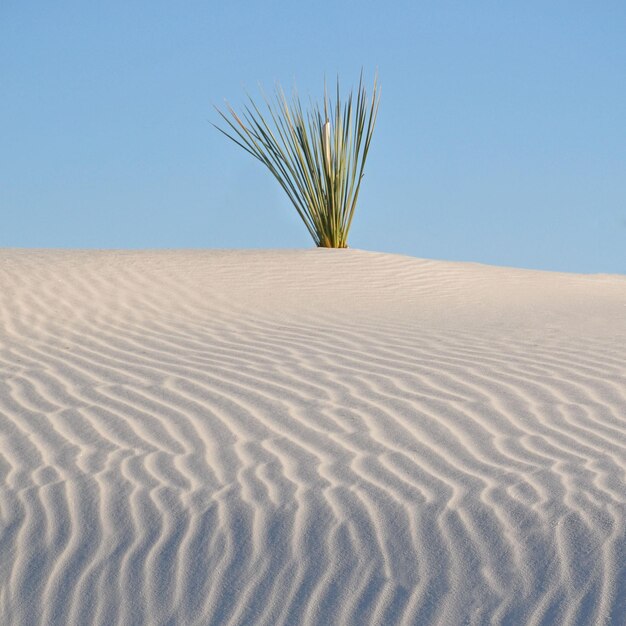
[216, 73, 380, 248]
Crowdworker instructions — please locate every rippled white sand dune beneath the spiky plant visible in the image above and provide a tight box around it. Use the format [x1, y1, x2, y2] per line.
[0, 250, 626, 626]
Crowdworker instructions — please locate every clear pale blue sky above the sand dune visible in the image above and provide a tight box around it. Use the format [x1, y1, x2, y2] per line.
[0, 0, 626, 274]
